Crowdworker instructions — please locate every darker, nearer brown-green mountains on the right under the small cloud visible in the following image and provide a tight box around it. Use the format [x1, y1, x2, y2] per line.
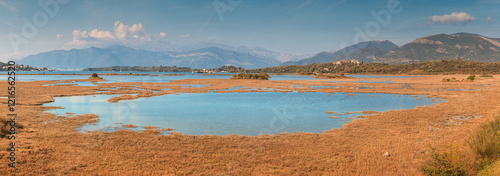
[281, 33, 500, 65]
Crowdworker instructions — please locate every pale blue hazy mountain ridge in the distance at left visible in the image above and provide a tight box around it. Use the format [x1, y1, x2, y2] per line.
[19, 42, 309, 70]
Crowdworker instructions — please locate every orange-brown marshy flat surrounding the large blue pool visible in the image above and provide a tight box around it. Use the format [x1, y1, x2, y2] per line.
[0, 75, 500, 175]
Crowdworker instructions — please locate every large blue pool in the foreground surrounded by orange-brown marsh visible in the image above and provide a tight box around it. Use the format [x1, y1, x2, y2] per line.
[46, 92, 441, 136]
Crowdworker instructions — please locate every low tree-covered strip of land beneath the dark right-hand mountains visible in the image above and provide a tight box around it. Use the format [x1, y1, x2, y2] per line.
[216, 59, 500, 75]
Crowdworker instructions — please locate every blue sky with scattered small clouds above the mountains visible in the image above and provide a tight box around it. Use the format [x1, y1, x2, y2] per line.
[0, 0, 500, 62]
